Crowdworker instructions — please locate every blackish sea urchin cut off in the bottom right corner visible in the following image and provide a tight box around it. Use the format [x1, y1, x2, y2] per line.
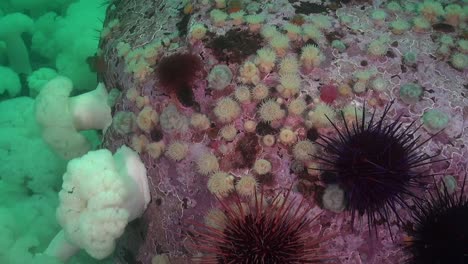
[405, 175, 468, 264]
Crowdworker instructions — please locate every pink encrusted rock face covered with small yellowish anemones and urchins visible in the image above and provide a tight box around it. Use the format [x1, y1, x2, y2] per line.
[97, 0, 468, 263]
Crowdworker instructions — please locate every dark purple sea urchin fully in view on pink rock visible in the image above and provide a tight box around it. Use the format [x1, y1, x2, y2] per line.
[315, 101, 435, 229]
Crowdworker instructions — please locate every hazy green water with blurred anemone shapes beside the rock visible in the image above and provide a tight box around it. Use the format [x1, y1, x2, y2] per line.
[0, 0, 111, 264]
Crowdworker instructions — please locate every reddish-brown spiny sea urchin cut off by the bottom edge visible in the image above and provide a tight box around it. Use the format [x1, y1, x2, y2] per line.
[189, 190, 333, 264]
